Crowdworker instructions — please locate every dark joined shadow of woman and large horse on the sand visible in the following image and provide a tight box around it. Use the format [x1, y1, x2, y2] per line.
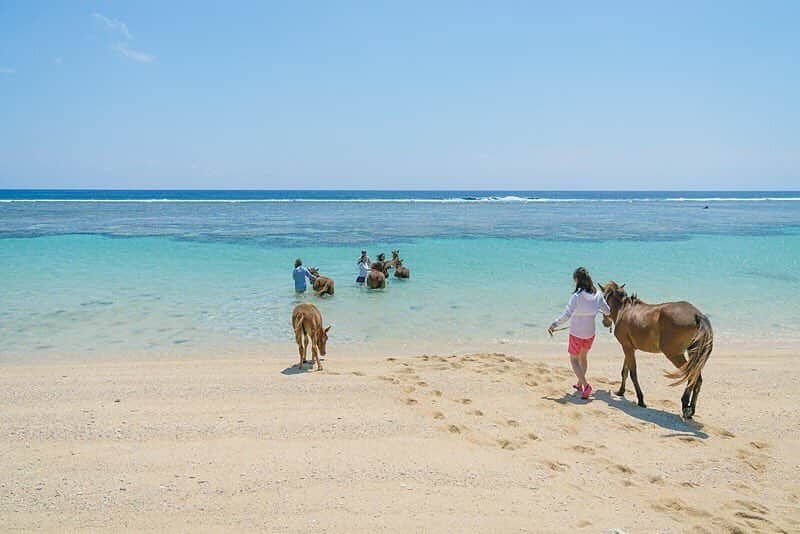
[542, 390, 708, 439]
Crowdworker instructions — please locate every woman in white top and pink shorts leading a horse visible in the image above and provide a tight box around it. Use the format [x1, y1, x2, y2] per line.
[547, 267, 611, 399]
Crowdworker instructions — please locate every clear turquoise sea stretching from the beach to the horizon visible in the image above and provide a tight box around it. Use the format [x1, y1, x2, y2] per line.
[0, 191, 800, 361]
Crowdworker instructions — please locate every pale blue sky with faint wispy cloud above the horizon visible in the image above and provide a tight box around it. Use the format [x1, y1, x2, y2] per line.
[0, 0, 800, 189]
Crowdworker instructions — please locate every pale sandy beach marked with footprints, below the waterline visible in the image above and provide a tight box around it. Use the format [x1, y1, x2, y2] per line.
[0, 346, 800, 533]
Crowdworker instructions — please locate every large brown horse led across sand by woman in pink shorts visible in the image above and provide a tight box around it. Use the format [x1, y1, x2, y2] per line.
[600, 282, 714, 419]
